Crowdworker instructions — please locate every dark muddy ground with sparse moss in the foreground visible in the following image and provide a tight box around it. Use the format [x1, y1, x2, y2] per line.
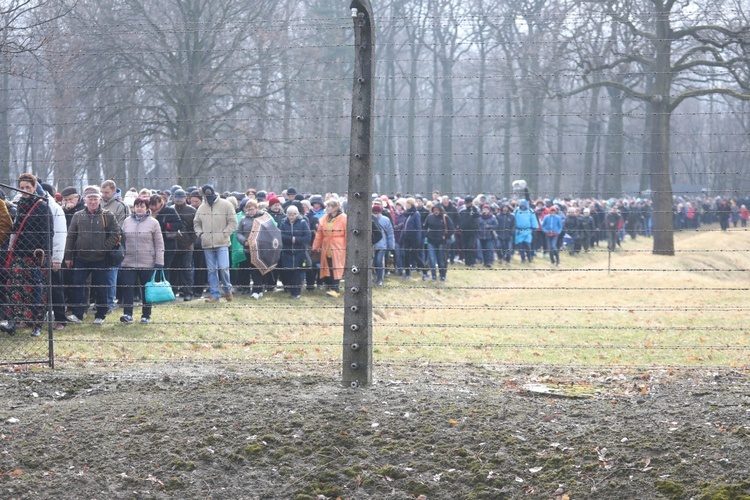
[0, 364, 750, 499]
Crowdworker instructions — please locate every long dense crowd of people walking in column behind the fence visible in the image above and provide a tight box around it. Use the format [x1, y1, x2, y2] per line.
[0, 173, 750, 336]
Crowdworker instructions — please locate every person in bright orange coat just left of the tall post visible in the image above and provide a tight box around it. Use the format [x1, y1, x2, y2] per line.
[312, 199, 346, 297]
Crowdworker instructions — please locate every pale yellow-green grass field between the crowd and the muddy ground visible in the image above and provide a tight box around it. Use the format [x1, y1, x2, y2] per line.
[55, 227, 750, 367]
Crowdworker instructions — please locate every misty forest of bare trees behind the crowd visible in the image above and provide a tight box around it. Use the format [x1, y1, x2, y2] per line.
[0, 0, 750, 201]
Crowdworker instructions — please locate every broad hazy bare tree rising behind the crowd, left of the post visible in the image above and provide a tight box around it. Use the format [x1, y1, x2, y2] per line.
[76, 0, 282, 184]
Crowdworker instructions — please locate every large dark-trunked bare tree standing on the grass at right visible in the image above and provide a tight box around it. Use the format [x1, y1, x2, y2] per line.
[577, 0, 750, 255]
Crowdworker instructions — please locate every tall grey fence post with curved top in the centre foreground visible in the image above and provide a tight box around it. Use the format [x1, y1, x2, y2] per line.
[342, 0, 375, 387]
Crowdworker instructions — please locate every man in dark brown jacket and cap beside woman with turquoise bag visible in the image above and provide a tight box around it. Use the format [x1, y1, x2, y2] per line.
[65, 186, 120, 325]
